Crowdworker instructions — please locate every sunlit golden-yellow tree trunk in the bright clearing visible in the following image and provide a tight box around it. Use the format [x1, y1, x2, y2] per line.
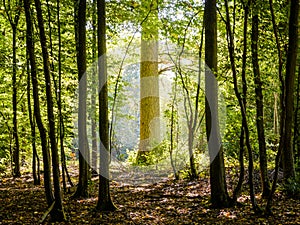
[137, 0, 160, 163]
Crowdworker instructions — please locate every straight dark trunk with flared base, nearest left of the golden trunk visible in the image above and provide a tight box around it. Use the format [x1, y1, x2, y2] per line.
[97, 0, 116, 211]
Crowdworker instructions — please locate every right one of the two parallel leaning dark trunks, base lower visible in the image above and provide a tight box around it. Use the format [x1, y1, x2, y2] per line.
[35, 0, 66, 221]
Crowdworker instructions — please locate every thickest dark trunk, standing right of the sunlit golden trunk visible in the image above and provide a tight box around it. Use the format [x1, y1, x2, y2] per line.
[204, 0, 229, 208]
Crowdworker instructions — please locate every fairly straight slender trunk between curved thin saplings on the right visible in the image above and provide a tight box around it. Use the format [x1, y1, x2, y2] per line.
[251, 0, 270, 198]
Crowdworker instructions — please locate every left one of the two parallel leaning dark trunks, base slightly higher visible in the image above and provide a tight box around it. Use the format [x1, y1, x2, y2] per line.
[24, 0, 54, 207]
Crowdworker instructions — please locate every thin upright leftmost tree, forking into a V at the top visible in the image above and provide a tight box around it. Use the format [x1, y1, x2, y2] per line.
[3, 0, 21, 177]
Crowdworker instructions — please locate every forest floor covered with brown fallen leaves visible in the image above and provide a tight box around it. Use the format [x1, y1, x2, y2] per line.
[0, 166, 300, 225]
